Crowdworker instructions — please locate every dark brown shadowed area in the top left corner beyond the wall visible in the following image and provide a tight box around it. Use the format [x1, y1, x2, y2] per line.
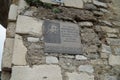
[0, 0, 11, 28]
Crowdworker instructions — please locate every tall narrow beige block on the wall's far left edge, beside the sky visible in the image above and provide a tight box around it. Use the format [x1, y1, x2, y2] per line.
[2, 38, 14, 70]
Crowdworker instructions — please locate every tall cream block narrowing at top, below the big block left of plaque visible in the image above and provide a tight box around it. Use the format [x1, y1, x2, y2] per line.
[12, 34, 27, 65]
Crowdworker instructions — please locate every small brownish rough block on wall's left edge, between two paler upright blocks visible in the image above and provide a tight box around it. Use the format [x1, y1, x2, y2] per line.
[6, 22, 16, 38]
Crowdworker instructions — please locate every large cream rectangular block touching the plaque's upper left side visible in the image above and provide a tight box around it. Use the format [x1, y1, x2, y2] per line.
[16, 15, 43, 36]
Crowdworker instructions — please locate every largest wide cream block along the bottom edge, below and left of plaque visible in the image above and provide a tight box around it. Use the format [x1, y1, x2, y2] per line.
[10, 65, 62, 80]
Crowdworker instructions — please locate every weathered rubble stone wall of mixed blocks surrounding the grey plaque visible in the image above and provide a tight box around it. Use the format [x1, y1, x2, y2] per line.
[2, 0, 120, 80]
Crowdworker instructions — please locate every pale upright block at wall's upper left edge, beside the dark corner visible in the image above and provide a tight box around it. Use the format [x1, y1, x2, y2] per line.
[8, 4, 18, 21]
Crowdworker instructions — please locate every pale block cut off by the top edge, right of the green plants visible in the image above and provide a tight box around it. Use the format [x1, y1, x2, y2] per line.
[64, 0, 83, 8]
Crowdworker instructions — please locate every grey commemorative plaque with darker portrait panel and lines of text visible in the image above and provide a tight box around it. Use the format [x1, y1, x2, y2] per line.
[43, 20, 82, 54]
